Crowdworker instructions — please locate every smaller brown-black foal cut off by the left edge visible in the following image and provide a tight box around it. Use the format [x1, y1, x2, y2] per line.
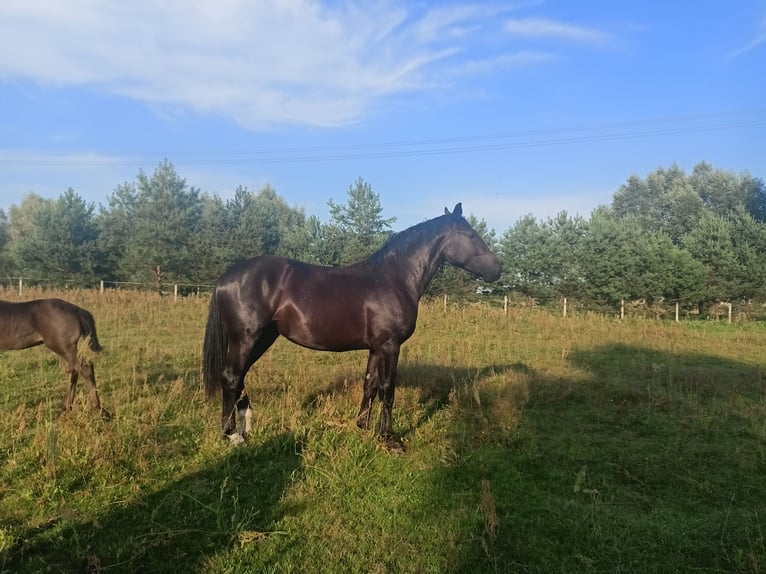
[0, 299, 102, 410]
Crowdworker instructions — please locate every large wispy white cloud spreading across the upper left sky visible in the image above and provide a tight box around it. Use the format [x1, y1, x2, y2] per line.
[0, 0, 552, 127]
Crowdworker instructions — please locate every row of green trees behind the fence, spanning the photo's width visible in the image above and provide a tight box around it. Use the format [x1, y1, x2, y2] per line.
[0, 161, 766, 316]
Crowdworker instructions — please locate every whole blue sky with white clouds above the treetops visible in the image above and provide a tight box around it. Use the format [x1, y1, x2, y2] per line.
[0, 0, 766, 233]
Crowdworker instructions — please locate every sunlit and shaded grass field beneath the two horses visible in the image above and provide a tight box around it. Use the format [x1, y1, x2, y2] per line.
[0, 291, 766, 574]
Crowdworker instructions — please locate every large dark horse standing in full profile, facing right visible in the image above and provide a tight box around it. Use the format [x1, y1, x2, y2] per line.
[203, 203, 500, 448]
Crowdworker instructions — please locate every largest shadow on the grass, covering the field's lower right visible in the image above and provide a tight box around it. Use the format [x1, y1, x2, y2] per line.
[432, 345, 766, 573]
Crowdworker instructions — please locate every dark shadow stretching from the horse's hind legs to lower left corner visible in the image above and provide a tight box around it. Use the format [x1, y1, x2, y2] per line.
[0, 433, 301, 573]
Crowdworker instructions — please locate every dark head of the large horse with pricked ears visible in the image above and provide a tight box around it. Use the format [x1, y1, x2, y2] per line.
[443, 203, 501, 281]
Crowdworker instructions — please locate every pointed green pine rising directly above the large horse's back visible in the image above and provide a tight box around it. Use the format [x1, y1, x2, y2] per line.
[327, 177, 396, 263]
